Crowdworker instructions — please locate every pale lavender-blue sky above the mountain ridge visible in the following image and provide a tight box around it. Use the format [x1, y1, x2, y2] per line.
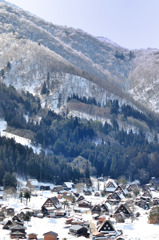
[8, 0, 159, 49]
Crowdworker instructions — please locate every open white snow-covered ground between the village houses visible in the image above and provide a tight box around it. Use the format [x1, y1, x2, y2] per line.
[0, 179, 159, 240]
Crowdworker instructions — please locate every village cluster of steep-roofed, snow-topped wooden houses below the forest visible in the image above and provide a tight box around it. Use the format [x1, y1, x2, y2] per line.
[0, 179, 159, 240]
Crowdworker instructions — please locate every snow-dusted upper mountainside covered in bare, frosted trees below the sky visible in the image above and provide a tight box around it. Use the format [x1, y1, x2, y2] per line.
[0, 1, 159, 119]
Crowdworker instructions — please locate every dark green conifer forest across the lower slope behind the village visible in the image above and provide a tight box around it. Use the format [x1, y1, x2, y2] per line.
[0, 84, 159, 184]
